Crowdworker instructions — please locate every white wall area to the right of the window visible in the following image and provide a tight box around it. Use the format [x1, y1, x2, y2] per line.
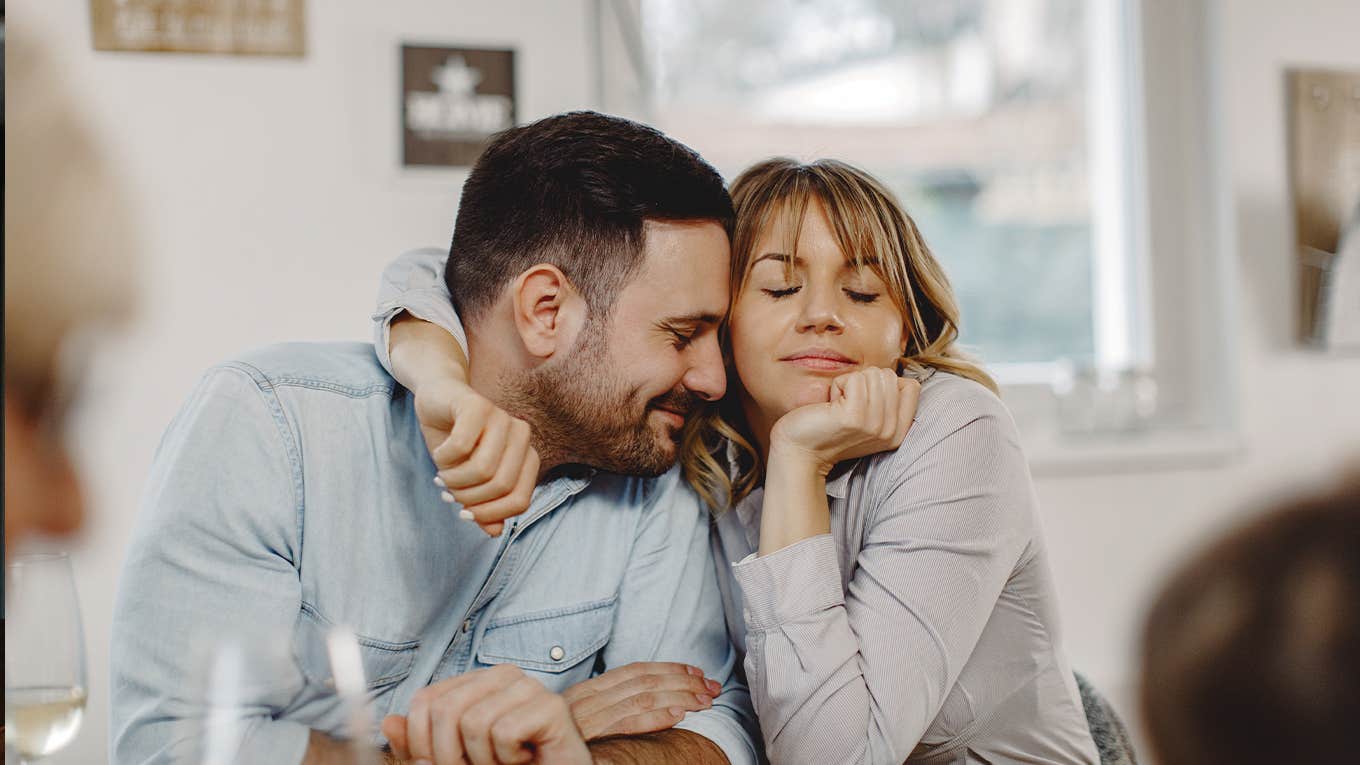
[1038, 0, 1360, 740]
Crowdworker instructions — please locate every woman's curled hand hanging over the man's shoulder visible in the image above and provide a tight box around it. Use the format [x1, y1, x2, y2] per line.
[415, 377, 539, 536]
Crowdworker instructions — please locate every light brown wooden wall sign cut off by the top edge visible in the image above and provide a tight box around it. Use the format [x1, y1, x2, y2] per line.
[90, 0, 307, 56]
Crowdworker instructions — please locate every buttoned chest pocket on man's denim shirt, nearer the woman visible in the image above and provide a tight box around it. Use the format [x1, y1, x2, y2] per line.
[477, 598, 617, 674]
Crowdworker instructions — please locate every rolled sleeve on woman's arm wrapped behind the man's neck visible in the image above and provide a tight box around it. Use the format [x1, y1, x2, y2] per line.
[373, 248, 472, 374]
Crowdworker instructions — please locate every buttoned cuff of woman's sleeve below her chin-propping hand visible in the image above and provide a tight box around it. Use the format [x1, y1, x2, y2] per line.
[732, 534, 845, 630]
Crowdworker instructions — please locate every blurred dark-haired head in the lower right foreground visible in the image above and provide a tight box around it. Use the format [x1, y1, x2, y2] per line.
[1142, 475, 1360, 765]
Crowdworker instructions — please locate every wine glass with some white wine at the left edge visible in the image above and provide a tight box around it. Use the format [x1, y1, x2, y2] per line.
[4, 553, 86, 762]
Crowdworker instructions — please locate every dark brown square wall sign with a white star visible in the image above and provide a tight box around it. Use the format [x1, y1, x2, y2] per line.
[401, 45, 515, 167]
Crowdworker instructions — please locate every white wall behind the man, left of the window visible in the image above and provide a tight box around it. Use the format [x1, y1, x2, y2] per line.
[7, 0, 593, 764]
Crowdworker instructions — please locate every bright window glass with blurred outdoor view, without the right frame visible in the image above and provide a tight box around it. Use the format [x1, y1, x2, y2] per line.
[605, 0, 1136, 381]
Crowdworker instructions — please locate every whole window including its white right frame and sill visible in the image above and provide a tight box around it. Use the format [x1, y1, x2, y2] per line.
[596, 0, 1221, 470]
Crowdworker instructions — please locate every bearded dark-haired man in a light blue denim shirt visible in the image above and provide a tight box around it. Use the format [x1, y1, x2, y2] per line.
[112, 113, 756, 764]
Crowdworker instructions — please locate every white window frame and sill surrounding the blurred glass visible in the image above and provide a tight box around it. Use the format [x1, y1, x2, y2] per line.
[592, 0, 1242, 475]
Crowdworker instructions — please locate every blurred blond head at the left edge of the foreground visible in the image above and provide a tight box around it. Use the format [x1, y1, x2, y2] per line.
[3, 25, 133, 558]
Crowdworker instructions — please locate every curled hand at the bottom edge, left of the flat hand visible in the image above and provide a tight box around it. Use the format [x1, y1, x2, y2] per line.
[382, 664, 592, 765]
